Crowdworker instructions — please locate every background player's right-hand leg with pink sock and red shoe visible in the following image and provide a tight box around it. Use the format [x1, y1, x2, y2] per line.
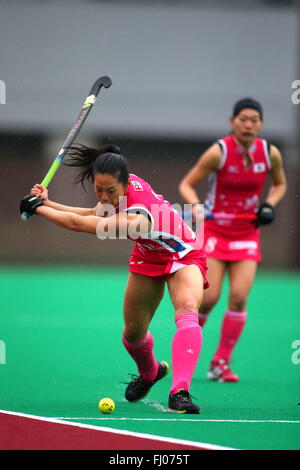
[209, 260, 257, 382]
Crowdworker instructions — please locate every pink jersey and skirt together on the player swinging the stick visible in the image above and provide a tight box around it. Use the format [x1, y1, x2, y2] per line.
[119, 174, 208, 287]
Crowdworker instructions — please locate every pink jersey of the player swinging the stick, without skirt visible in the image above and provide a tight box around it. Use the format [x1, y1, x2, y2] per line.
[119, 174, 201, 263]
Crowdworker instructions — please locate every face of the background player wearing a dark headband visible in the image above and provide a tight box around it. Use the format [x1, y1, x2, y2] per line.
[230, 109, 262, 145]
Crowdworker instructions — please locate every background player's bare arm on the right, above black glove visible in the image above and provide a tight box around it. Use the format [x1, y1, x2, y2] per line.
[266, 145, 287, 206]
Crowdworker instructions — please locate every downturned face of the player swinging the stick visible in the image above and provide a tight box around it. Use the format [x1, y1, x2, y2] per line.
[94, 173, 127, 207]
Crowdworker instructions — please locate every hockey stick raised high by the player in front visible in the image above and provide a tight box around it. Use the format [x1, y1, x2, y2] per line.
[21, 76, 112, 222]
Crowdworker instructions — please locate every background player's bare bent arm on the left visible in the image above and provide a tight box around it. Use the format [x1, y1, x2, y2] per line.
[179, 144, 222, 204]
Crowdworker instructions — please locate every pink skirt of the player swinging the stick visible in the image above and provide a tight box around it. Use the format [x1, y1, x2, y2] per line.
[129, 250, 209, 289]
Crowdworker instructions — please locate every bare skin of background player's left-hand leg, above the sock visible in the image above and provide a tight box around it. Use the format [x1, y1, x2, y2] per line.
[198, 258, 227, 327]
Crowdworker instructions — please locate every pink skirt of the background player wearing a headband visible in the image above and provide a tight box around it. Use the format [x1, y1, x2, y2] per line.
[204, 224, 261, 263]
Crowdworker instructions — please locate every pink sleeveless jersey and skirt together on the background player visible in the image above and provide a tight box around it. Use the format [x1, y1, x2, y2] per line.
[205, 135, 271, 262]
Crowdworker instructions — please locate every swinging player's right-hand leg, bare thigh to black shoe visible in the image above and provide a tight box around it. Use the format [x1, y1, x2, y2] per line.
[168, 265, 203, 413]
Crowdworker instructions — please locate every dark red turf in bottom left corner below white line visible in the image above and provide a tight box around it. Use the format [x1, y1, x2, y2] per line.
[0, 412, 204, 450]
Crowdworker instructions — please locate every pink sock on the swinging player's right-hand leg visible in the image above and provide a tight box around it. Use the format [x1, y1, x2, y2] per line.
[171, 313, 202, 394]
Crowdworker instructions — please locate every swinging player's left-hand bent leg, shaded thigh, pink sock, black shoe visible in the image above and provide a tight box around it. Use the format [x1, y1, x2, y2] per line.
[123, 273, 169, 401]
